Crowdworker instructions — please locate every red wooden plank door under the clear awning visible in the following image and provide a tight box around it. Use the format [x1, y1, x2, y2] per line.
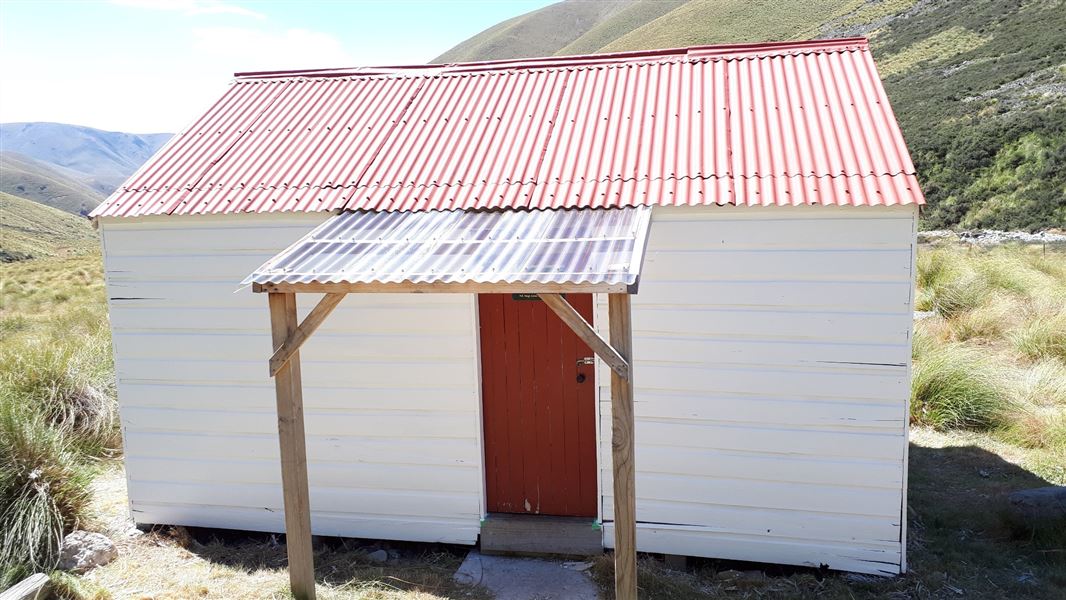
[478, 294, 596, 517]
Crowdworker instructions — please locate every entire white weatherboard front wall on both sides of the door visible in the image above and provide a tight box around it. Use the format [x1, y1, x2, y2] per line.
[101, 207, 917, 572]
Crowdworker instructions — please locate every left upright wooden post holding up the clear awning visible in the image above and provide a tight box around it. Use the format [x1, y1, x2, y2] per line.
[269, 293, 314, 600]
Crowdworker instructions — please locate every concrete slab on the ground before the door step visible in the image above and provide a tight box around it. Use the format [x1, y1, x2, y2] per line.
[455, 550, 599, 600]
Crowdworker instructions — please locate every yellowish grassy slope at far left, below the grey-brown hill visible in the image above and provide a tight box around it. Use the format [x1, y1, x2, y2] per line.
[0, 192, 97, 262]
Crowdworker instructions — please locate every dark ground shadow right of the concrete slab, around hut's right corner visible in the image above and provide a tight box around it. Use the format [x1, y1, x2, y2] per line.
[594, 443, 1066, 600]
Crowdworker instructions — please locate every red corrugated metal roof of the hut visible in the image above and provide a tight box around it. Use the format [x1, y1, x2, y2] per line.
[93, 38, 923, 216]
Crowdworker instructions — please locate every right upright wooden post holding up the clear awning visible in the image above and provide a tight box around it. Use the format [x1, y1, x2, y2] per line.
[608, 294, 636, 600]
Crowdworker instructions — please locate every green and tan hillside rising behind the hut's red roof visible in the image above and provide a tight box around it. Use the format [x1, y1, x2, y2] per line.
[435, 0, 1066, 230]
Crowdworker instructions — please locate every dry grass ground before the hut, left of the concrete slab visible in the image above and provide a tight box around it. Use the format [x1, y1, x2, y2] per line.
[80, 465, 488, 600]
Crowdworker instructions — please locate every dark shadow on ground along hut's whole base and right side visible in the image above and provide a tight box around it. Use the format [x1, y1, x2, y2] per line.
[159, 443, 1066, 600]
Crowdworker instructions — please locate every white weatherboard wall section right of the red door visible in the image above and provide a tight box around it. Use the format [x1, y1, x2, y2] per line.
[596, 207, 917, 573]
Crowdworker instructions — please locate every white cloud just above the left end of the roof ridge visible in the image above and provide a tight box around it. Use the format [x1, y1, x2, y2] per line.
[193, 27, 353, 71]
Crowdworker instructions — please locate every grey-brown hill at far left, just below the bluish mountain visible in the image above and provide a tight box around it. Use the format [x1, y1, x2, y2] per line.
[0, 151, 104, 214]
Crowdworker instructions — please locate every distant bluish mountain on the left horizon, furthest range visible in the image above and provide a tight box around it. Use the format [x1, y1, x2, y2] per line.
[0, 123, 173, 196]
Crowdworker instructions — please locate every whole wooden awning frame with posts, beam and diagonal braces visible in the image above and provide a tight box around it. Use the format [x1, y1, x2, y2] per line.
[253, 282, 636, 600]
